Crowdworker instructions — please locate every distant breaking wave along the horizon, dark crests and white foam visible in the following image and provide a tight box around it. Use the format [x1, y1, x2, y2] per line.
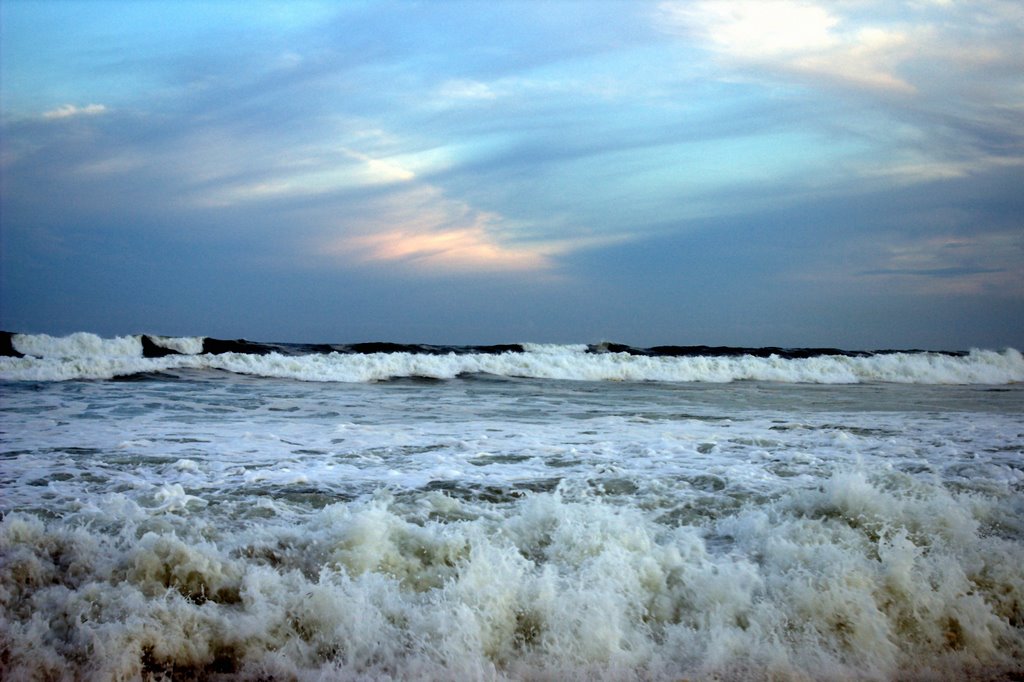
[0, 332, 1024, 384]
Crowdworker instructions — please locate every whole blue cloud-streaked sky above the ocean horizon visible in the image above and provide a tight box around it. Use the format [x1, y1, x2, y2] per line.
[0, 0, 1024, 349]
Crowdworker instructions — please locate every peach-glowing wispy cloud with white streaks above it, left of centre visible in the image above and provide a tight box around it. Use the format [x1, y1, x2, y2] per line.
[161, 122, 570, 274]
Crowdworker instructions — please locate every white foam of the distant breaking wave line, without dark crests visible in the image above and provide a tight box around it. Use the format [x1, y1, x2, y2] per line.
[0, 334, 1024, 384]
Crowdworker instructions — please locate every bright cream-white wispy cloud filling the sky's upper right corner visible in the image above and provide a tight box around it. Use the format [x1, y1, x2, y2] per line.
[654, 0, 1024, 184]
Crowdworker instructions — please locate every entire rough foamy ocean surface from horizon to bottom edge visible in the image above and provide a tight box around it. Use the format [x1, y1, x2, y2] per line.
[0, 334, 1024, 681]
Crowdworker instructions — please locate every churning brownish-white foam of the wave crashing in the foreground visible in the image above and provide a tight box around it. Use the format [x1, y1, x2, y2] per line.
[0, 471, 1024, 680]
